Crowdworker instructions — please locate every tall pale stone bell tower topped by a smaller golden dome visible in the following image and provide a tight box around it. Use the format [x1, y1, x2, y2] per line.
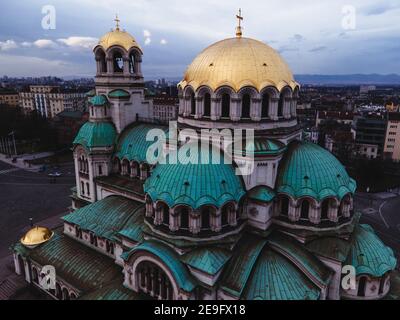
[93, 16, 150, 133]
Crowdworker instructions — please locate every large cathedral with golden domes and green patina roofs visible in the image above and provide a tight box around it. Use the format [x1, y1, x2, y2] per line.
[13, 15, 397, 300]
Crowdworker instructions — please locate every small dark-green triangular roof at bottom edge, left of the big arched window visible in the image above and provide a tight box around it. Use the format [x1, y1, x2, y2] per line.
[79, 276, 142, 300]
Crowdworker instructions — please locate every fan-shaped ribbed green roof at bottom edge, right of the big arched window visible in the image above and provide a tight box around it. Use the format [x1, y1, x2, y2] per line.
[242, 247, 320, 300]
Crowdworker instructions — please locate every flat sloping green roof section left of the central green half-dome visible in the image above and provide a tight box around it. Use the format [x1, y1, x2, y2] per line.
[62, 196, 143, 240]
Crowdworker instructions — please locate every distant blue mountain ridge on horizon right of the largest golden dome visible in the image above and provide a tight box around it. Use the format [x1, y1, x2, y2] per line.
[295, 74, 400, 85]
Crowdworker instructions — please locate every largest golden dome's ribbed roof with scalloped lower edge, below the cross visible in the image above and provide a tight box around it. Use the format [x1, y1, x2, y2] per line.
[180, 36, 298, 92]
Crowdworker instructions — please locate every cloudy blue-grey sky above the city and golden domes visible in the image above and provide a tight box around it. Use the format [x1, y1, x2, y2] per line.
[0, 0, 400, 79]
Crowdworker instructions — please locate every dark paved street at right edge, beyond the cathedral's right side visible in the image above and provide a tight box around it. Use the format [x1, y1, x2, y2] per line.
[355, 192, 400, 261]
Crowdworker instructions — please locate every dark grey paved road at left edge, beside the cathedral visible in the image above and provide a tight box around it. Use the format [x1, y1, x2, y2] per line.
[0, 161, 75, 258]
